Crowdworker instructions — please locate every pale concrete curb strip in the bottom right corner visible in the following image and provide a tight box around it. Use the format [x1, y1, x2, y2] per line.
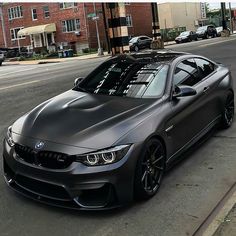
[193, 183, 236, 236]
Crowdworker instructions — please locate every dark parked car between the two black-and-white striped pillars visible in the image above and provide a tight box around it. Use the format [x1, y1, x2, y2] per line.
[129, 35, 152, 52]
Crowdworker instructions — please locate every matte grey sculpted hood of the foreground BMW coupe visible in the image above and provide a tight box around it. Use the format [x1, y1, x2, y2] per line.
[12, 90, 157, 149]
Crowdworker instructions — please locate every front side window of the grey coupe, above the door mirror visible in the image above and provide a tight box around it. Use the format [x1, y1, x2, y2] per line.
[174, 59, 199, 86]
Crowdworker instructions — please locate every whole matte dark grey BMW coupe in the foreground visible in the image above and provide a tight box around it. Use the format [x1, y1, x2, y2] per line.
[3, 51, 234, 209]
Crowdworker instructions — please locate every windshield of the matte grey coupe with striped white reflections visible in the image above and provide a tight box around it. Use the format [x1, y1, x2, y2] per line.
[75, 61, 169, 98]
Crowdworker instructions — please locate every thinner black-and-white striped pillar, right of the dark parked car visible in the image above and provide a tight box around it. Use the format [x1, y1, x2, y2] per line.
[151, 2, 164, 49]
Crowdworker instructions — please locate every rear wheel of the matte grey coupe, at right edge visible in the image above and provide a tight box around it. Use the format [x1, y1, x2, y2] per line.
[221, 92, 234, 129]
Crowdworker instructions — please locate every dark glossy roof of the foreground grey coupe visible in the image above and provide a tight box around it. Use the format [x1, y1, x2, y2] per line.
[110, 50, 189, 64]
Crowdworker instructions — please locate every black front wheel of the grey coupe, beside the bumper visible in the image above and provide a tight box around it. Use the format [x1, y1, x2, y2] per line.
[134, 139, 166, 200]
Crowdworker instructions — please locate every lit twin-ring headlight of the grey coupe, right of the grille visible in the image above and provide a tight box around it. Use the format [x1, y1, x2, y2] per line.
[75, 145, 130, 166]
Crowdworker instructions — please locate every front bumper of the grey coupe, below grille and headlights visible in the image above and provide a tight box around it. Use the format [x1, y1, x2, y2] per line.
[3, 140, 140, 210]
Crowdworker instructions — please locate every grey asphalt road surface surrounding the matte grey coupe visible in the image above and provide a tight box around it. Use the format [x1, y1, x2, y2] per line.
[0, 37, 236, 236]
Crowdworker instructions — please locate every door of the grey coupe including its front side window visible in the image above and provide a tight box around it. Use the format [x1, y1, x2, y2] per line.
[166, 58, 213, 157]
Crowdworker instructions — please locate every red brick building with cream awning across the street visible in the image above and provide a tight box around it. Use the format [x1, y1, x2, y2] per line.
[0, 2, 152, 52]
